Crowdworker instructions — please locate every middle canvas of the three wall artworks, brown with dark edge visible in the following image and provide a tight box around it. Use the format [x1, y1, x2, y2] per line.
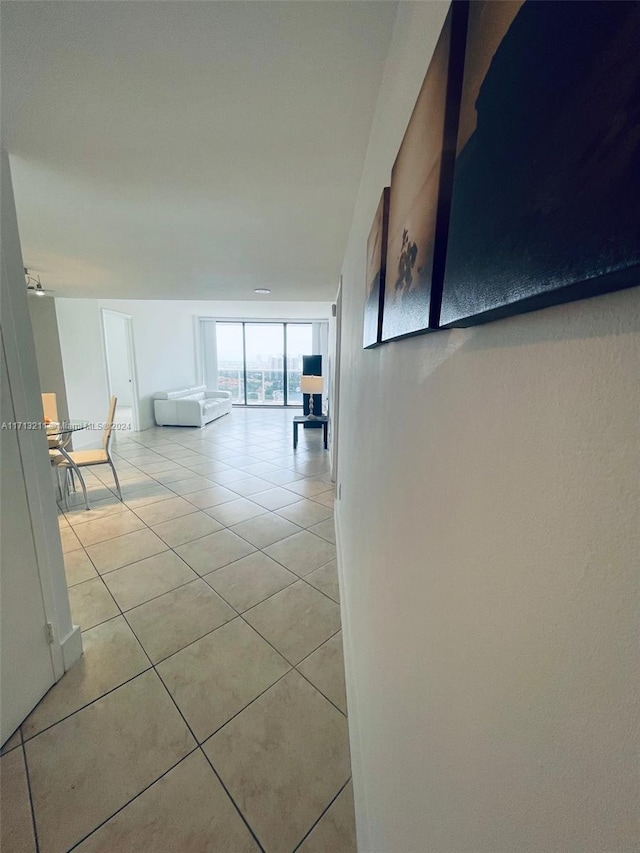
[382, 0, 468, 341]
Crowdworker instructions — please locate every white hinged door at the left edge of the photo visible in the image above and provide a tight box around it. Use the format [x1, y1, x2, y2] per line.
[0, 336, 55, 744]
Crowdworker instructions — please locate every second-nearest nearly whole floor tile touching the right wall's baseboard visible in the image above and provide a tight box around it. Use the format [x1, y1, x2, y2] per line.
[243, 581, 340, 664]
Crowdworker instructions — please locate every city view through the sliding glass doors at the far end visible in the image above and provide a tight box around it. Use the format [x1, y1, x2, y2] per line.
[216, 322, 312, 406]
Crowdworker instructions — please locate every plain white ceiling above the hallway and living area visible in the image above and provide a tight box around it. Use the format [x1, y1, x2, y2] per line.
[2, 0, 396, 300]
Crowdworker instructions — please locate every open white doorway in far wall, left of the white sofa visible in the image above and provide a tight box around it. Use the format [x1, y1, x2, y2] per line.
[102, 308, 140, 431]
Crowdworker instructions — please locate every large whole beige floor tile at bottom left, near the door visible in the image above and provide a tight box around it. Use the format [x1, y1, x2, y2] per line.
[26, 671, 194, 853]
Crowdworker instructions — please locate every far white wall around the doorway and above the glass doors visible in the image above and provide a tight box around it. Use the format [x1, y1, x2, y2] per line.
[56, 299, 331, 432]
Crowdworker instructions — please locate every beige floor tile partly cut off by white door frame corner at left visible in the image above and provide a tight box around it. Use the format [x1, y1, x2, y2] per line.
[22, 616, 151, 738]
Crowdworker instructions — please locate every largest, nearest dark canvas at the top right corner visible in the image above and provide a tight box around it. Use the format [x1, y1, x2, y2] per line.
[440, 0, 640, 326]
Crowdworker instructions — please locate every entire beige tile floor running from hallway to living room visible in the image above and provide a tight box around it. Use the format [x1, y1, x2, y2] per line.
[0, 409, 356, 853]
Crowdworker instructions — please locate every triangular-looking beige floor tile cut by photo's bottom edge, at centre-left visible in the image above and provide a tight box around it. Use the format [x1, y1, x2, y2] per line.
[75, 750, 258, 853]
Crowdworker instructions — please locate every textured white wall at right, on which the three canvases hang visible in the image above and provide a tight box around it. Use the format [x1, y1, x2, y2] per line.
[336, 3, 640, 853]
